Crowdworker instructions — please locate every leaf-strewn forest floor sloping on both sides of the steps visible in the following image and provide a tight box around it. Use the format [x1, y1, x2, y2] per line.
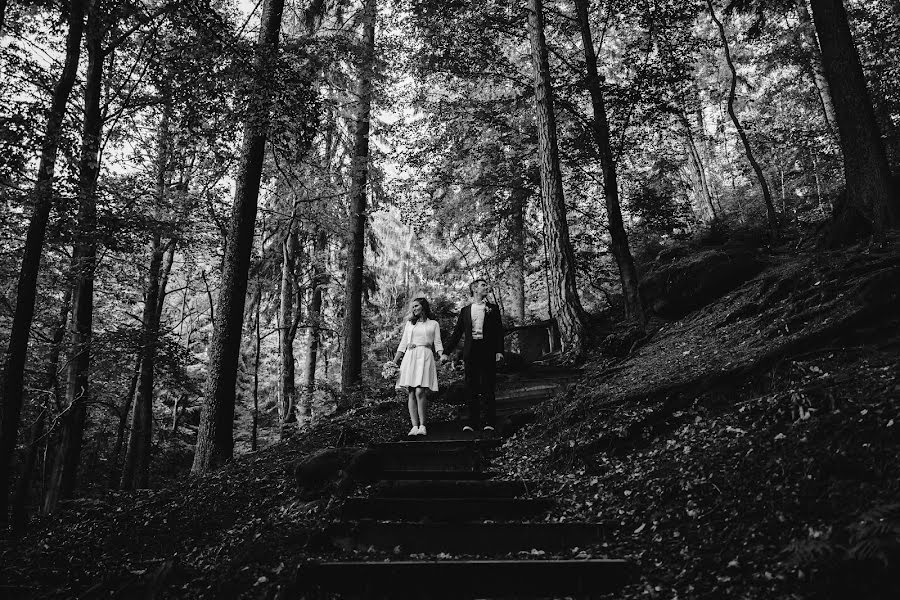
[0, 230, 900, 599]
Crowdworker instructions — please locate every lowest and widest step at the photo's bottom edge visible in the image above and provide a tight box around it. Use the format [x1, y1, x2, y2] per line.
[288, 559, 632, 599]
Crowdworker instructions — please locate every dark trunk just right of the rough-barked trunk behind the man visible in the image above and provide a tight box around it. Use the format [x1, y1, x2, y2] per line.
[575, 0, 647, 327]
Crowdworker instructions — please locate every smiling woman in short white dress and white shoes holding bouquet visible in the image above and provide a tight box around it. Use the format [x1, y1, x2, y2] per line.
[394, 298, 444, 435]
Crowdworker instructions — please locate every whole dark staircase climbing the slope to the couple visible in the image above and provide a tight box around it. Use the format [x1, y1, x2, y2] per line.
[290, 368, 630, 599]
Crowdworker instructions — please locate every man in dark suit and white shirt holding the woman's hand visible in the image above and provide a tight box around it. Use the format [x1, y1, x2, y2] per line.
[441, 279, 503, 435]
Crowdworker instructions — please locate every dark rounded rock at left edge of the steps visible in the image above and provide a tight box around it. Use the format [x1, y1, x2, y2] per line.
[294, 446, 382, 500]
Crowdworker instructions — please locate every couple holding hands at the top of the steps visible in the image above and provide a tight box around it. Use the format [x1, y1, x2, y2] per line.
[394, 279, 503, 436]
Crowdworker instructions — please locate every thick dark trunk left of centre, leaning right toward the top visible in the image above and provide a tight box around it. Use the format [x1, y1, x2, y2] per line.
[191, 0, 284, 473]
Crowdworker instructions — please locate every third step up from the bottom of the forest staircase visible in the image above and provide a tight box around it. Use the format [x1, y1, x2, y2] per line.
[341, 497, 553, 522]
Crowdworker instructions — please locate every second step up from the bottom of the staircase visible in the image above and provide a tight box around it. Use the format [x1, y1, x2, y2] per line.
[328, 521, 604, 556]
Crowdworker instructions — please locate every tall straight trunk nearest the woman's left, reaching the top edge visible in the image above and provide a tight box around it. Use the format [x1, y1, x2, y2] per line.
[339, 0, 376, 394]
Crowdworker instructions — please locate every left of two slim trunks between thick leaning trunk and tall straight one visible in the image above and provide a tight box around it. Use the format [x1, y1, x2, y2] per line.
[278, 227, 299, 438]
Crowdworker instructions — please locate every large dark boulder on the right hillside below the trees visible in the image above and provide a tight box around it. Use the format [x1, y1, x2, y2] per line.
[641, 248, 764, 320]
